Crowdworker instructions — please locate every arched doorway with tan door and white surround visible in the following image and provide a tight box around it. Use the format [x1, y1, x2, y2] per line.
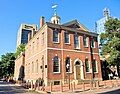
[74, 59, 84, 80]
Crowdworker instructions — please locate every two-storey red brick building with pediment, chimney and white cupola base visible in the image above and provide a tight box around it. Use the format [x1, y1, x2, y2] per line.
[24, 15, 102, 86]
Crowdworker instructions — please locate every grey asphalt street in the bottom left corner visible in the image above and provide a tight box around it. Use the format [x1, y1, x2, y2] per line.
[0, 81, 40, 94]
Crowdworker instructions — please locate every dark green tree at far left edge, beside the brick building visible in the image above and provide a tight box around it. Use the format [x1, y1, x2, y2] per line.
[0, 53, 15, 77]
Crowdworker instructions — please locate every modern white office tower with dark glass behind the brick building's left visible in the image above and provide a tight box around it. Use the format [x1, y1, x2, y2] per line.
[17, 24, 37, 47]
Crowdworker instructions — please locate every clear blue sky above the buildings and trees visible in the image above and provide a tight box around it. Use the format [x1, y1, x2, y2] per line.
[0, 0, 120, 56]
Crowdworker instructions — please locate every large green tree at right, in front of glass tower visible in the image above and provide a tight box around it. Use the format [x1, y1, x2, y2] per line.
[100, 18, 120, 75]
